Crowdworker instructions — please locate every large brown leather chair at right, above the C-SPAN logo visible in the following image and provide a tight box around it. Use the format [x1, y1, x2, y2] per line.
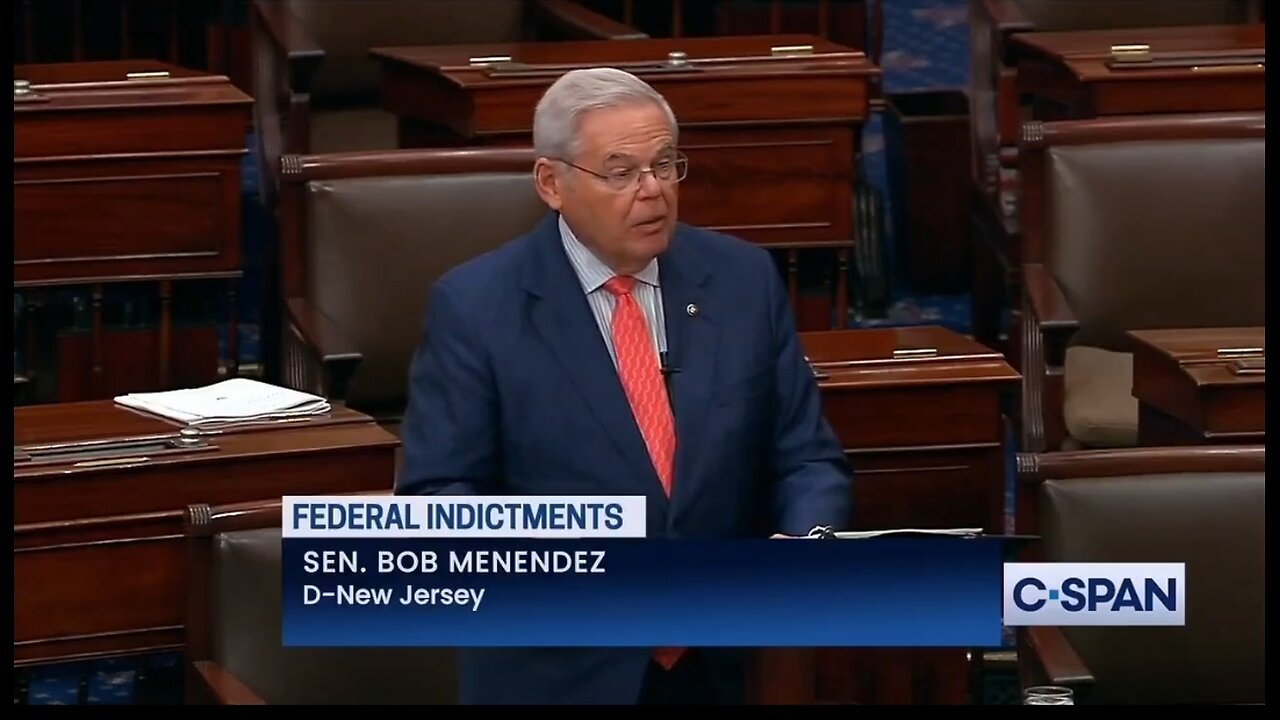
[1020, 113, 1266, 452]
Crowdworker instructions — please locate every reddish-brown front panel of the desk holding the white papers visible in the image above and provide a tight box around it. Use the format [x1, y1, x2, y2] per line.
[13, 442, 396, 665]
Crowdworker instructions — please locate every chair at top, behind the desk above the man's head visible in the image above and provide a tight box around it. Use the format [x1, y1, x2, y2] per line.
[251, 0, 645, 206]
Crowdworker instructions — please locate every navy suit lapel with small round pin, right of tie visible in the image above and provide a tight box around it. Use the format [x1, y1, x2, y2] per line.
[658, 221, 724, 519]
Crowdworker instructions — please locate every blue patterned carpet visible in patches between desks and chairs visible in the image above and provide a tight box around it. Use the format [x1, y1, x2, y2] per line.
[14, 0, 1016, 705]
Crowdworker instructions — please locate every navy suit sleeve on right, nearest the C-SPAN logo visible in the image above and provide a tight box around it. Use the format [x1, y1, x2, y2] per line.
[765, 252, 852, 536]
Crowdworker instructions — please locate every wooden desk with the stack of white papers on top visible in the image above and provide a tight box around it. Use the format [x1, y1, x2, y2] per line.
[13, 401, 399, 665]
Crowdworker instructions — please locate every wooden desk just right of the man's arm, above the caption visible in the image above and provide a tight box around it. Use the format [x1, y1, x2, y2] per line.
[800, 325, 1019, 533]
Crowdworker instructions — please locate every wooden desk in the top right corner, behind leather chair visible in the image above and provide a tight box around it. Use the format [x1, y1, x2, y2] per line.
[1010, 24, 1266, 119]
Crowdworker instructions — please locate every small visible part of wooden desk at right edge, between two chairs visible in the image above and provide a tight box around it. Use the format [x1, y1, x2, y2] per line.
[1129, 328, 1266, 445]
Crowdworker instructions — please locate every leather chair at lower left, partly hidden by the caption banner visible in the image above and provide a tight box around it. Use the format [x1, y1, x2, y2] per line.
[186, 491, 457, 705]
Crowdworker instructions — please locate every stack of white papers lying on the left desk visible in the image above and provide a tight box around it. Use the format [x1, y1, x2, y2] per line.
[115, 378, 330, 427]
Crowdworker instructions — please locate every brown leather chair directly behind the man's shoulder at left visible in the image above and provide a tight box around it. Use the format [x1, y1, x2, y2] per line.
[280, 147, 548, 432]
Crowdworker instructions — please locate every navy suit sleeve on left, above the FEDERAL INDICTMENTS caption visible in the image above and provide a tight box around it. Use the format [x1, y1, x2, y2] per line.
[396, 279, 500, 495]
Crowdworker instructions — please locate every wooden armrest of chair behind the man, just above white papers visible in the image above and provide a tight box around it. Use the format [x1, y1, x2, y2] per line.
[284, 297, 364, 402]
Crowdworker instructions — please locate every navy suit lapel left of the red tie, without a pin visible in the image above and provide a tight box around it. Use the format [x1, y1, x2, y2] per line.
[525, 214, 666, 502]
